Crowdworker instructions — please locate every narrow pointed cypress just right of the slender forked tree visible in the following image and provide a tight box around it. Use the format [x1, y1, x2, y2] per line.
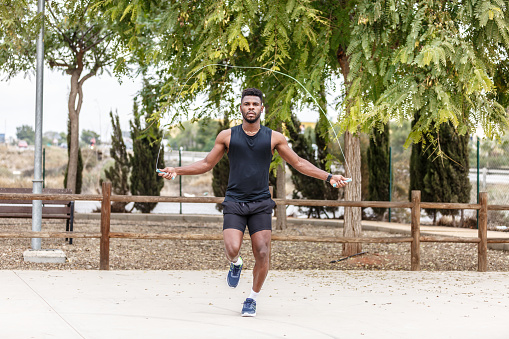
[104, 111, 131, 213]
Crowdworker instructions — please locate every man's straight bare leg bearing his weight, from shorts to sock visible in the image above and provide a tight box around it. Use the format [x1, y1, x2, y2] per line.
[251, 230, 272, 293]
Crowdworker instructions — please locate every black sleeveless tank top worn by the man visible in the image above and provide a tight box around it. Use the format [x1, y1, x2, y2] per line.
[224, 125, 272, 202]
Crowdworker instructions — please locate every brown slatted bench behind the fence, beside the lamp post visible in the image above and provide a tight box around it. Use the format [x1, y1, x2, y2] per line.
[0, 187, 74, 244]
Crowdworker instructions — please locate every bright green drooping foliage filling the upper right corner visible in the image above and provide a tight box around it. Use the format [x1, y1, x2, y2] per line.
[348, 0, 509, 147]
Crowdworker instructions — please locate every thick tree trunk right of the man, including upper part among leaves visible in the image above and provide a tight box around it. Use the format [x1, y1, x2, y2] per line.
[336, 45, 362, 256]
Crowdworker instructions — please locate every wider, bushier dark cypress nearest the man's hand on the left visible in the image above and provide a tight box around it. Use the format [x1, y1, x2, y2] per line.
[129, 91, 164, 213]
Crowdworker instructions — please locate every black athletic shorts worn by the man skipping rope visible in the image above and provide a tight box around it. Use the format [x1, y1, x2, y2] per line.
[222, 198, 276, 235]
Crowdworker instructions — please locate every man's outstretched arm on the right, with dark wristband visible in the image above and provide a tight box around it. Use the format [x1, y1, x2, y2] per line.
[272, 131, 347, 187]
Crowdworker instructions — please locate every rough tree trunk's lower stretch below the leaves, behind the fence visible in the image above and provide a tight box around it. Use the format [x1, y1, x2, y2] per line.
[343, 132, 362, 256]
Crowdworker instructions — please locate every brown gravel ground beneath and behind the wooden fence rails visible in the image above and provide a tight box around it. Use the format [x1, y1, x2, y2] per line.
[0, 219, 509, 271]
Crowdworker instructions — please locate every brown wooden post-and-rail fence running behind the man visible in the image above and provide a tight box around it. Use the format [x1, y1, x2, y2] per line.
[0, 183, 509, 272]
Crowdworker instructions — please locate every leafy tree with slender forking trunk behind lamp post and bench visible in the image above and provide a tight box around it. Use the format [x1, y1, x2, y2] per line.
[0, 0, 128, 192]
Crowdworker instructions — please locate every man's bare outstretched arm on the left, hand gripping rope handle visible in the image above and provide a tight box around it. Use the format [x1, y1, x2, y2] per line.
[159, 129, 231, 179]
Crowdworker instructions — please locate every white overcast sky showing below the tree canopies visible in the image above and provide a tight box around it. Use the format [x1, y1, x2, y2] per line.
[0, 68, 326, 141]
